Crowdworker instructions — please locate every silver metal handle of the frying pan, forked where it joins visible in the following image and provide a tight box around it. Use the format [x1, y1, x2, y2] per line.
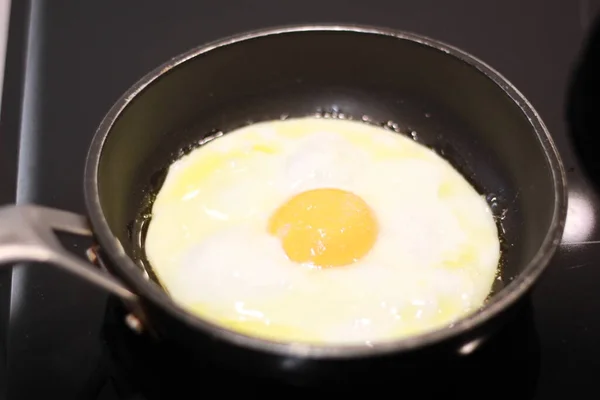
[0, 205, 138, 305]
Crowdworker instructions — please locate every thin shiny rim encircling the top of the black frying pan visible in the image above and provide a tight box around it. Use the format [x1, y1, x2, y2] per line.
[84, 23, 568, 359]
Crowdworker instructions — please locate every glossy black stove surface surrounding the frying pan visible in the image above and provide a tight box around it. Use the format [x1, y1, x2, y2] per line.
[0, 0, 600, 400]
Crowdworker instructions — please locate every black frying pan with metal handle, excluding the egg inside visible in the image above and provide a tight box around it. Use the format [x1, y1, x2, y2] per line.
[0, 25, 567, 384]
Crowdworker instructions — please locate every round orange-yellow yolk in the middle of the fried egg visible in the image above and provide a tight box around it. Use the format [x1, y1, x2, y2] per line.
[268, 188, 378, 267]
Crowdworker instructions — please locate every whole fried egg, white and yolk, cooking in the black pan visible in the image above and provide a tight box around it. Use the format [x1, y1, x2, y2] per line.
[145, 117, 500, 344]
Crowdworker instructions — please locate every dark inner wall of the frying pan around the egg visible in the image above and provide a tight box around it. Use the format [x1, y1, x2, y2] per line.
[98, 31, 555, 310]
